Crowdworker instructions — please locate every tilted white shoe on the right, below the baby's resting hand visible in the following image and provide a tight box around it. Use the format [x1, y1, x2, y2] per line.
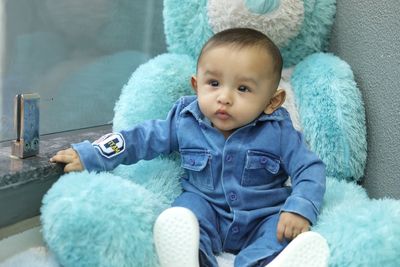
[267, 232, 329, 267]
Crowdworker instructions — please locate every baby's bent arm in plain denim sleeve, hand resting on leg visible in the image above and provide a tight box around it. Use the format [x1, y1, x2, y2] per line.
[277, 115, 326, 243]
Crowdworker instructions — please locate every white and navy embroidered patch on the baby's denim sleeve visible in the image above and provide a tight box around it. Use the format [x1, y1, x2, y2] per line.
[93, 133, 125, 158]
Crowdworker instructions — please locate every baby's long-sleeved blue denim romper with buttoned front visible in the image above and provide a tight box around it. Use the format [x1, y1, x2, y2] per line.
[72, 96, 325, 267]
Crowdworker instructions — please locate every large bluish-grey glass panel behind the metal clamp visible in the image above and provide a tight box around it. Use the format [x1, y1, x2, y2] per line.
[0, 0, 166, 141]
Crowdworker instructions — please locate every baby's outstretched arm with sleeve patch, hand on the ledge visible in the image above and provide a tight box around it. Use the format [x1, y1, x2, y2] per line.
[50, 98, 183, 172]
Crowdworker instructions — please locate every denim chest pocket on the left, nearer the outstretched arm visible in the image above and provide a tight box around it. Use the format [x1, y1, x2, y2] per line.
[180, 149, 214, 190]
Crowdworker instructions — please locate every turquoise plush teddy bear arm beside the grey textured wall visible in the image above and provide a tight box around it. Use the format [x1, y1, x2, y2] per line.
[292, 53, 367, 180]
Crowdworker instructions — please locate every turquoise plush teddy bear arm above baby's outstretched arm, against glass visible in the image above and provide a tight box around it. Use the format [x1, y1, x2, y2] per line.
[113, 54, 196, 131]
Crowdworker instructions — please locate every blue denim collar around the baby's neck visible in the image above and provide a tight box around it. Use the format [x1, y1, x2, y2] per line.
[180, 96, 289, 125]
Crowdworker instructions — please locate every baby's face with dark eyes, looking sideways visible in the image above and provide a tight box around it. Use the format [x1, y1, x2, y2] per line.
[192, 46, 276, 137]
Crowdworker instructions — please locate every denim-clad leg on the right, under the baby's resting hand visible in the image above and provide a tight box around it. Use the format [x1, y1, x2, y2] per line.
[235, 214, 288, 267]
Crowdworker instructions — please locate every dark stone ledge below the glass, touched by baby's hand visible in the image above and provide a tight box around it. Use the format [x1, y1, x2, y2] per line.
[0, 125, 111, 228]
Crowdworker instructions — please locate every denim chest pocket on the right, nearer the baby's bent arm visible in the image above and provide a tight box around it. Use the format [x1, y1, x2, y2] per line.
[242, 150, 280, 186]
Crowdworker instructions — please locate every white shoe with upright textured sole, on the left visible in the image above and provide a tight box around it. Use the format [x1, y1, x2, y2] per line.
[153, 207, 200, 267]
